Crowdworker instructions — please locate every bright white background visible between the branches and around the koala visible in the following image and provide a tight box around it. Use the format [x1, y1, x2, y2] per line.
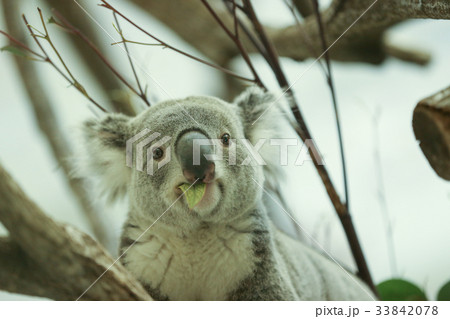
[0, 0, 450, 300]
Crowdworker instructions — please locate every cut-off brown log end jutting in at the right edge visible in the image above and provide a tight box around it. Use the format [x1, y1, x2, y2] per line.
[413, 87, 450, 181]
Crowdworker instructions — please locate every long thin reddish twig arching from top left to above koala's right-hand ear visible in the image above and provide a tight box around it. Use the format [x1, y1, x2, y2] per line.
[100, 0, 255, 83]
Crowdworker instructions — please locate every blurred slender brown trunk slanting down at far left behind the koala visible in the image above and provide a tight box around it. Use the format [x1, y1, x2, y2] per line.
[3, 1, 114, 249]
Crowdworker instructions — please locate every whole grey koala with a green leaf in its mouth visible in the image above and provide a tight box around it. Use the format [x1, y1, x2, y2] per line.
[83, 87, 374, 300]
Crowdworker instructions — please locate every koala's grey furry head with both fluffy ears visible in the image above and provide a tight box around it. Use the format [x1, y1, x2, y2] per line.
[84, 88, 284, 228]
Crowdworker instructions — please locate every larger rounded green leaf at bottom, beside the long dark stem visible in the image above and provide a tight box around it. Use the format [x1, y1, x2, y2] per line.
[377, 279, 427, 301]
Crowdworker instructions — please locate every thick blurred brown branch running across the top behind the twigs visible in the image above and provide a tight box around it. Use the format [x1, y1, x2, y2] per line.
[127, 0, 450, 65]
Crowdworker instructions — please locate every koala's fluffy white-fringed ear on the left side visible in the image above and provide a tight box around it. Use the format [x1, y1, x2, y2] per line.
[79, 114, 131, 200]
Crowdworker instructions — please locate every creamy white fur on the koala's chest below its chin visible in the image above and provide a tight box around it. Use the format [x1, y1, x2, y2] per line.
[124, 226, 254, 300]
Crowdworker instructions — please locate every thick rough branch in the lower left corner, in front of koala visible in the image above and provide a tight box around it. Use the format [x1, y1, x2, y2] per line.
[0, 165, 151, 300]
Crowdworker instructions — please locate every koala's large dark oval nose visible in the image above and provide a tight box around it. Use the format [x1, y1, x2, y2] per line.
[175, 131, 215, 183]
